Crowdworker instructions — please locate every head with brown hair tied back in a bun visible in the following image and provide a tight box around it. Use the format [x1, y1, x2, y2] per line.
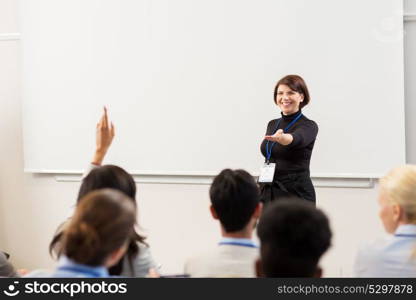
[62, 189, 136, 267]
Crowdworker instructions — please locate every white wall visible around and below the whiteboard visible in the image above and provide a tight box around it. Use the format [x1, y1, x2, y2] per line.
[0, 0, 416, 276]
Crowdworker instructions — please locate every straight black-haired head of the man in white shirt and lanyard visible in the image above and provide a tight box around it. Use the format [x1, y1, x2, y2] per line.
[209, 169, 261, 233]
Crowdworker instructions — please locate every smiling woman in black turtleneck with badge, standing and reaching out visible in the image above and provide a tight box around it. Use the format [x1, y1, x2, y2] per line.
[259, 75, 318, 203]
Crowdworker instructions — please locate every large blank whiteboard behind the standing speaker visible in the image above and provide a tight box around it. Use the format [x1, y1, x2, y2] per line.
[20, 0, 405, 177]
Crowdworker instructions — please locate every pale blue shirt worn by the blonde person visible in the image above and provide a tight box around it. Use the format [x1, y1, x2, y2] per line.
[354, 224, 416, 277]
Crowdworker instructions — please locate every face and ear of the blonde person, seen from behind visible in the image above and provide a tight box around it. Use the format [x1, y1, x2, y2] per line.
[378, 188, 400, 233]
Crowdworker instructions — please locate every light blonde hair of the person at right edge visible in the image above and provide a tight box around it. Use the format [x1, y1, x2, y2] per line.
[380, 165, 416, 224]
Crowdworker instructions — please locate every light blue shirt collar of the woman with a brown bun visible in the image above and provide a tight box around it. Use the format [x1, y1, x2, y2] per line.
[51, 255, 110, 278]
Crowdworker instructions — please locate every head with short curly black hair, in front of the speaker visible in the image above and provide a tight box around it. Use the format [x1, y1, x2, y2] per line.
[256, 198, 332, 277]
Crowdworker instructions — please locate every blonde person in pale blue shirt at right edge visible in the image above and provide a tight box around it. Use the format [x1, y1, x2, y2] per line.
[354, 165, 416, 277]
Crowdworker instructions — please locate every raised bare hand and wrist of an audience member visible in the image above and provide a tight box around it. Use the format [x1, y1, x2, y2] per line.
[91, 107, 115, 166]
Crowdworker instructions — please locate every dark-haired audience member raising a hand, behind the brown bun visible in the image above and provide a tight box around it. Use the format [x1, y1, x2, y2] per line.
[49, 109, 156, 277]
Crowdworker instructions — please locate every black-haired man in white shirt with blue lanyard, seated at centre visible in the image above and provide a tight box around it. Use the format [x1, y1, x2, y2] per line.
[185, 169, 262, 277]
